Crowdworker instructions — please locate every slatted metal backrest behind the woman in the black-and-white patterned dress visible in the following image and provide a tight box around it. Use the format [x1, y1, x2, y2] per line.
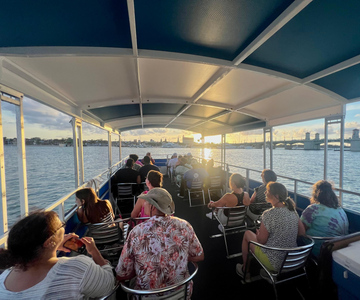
[279, 237, 314, 274]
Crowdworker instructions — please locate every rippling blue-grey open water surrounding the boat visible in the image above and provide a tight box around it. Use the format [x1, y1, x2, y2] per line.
[5, 145, 360, 225]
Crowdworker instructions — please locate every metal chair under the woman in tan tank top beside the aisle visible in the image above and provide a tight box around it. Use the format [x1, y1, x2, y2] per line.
[210, 205, 247, 259]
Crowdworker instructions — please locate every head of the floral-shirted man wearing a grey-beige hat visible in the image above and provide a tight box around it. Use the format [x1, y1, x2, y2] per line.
[139, 188, 175, 217]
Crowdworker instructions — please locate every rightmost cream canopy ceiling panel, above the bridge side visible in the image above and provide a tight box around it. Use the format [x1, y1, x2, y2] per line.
[247, 86, 339, 120]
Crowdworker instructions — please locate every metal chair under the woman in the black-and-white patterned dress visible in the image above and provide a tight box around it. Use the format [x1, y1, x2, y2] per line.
[244, 237, 314, 299]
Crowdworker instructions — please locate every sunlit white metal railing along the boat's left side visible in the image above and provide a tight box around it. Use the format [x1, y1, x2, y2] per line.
[0, 157, 128, 247]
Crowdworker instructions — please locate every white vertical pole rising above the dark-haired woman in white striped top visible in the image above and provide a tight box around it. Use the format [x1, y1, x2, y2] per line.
[16, 97, 29, 216]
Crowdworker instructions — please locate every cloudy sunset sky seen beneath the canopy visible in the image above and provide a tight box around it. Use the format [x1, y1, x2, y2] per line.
[2, 97, 360, 143]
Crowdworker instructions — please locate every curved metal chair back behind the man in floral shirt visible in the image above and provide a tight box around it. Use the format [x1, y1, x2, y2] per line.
[120, 262, 198, 300]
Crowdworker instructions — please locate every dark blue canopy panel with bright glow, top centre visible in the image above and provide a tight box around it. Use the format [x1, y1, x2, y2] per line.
[134, 0, 293, 60]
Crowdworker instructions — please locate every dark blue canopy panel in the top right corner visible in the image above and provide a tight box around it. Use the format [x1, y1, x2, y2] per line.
[244, 0, 360, 78]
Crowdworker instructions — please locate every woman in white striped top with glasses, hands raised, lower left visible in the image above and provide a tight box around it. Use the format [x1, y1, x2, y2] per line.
[0, 211, 115, 299]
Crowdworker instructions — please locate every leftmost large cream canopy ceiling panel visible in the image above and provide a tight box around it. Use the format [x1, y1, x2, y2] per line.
[7, 57, 138, 105]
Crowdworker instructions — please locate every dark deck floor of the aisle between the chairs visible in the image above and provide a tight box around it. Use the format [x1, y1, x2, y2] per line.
[118, 178, 311, 300]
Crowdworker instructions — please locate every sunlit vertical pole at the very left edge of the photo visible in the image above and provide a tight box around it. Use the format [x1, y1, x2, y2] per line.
[0, 101, 8, 235]
